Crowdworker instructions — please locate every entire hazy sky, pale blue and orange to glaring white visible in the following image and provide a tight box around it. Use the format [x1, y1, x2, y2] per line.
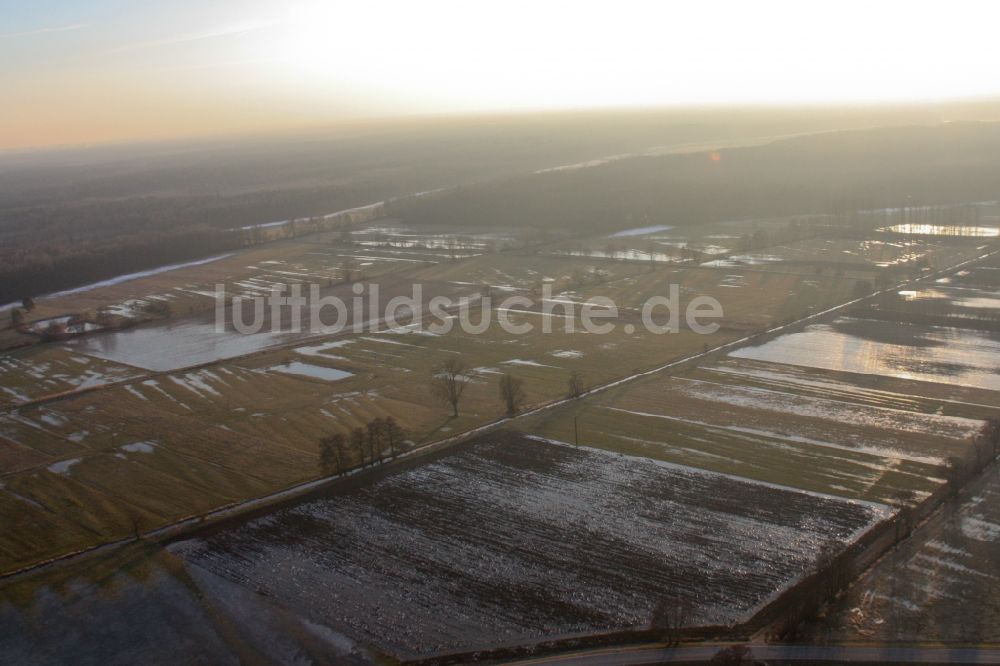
[0, 0, 1000, 148]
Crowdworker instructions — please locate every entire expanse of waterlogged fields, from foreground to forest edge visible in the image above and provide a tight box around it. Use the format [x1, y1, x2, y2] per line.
[0, 214, 1000, 662]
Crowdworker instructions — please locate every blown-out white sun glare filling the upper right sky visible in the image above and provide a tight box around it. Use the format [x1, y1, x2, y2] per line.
[248, 0, 994, 113]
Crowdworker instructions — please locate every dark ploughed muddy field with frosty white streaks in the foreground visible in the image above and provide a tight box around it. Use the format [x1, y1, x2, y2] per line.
[169, 434, 888, 657]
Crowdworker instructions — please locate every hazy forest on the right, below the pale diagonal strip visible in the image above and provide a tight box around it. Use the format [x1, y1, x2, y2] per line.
[389, 123, 1000, 233]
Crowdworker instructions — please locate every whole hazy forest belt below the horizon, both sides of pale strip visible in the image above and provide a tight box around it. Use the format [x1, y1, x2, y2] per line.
[0, 114, 1000, 303]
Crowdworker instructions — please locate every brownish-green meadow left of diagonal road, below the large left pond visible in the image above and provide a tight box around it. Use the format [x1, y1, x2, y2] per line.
[0, 298, 734, 568]
